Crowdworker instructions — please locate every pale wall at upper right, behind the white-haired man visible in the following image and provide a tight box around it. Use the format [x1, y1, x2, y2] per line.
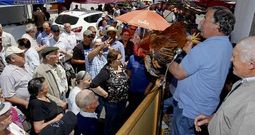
[231, 0, 255, 43]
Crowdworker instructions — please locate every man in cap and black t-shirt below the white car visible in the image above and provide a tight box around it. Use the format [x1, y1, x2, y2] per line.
[71, 30, 95, 73]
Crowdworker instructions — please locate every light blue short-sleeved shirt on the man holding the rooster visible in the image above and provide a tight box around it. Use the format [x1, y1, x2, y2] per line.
[174, 36, 233, 119]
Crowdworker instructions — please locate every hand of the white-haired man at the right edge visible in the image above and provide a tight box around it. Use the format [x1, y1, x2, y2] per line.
[194, 114, 212, 132]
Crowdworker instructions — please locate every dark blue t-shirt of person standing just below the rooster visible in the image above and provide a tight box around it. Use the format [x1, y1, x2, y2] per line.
[127, 55, 149, 93]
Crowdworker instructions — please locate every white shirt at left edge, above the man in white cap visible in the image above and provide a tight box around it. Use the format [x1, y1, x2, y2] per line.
[1, 31, 18, 49]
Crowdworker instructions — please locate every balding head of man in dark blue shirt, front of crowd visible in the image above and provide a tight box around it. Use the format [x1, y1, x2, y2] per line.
[75, 90, 95, 110]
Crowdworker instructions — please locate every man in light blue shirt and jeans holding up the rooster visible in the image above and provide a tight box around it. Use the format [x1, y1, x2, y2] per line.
[169, 7, 235, 135]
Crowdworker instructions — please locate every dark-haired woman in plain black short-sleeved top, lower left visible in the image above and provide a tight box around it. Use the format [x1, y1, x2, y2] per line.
[28, 77, 76, 135]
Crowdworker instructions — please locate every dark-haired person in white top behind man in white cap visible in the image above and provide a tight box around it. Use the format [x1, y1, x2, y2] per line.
[18, 38, 40, 71]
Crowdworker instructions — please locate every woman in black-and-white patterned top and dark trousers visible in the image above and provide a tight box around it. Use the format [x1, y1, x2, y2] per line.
[90, 50, 128, 135]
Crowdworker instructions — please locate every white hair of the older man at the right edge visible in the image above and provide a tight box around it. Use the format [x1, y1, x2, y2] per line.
[236, 36, 255, 62]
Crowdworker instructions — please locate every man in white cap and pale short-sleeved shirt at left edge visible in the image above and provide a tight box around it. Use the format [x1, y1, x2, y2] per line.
[0, 46, 32, 113]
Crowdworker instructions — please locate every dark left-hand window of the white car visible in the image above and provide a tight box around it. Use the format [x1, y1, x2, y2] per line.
[55, 15, 79, 25]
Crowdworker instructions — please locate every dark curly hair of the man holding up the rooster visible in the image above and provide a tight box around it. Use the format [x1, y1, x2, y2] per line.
[208, 6, 236, 35]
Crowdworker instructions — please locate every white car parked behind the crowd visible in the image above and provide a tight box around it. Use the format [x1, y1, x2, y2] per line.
[53, 11, 103, 40]
